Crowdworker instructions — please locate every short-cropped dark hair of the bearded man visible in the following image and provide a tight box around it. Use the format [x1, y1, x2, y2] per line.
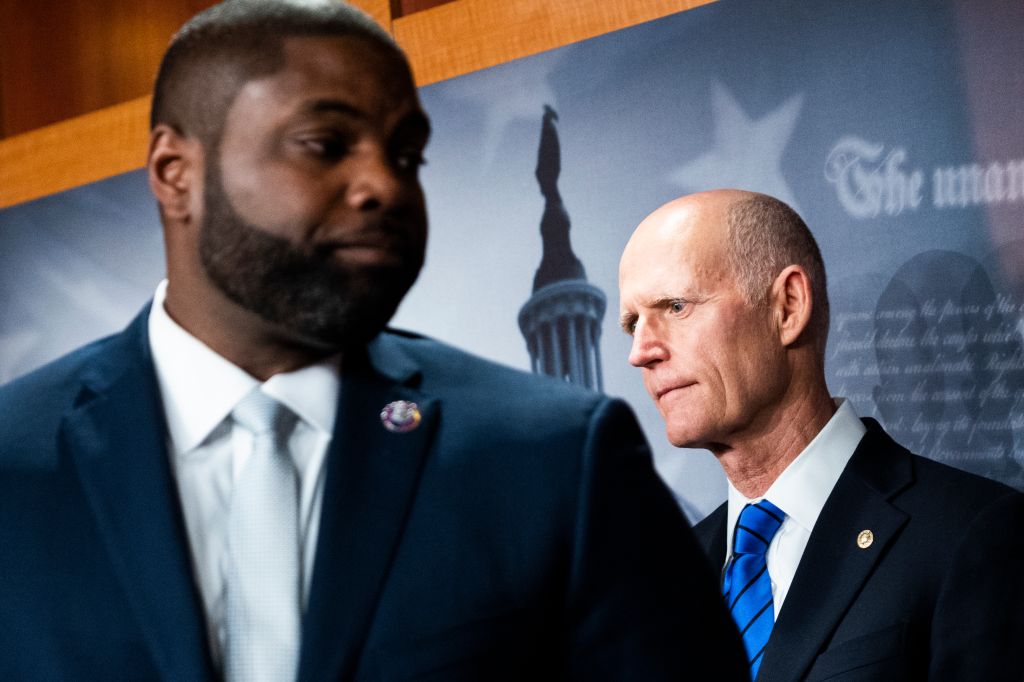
[150, 0, 412, 148]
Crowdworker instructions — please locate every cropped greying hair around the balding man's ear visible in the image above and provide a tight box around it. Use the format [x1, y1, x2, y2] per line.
[727, 195, 828, 353]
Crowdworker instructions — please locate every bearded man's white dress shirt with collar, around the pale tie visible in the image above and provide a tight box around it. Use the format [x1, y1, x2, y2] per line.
[148, 281, 340, 662]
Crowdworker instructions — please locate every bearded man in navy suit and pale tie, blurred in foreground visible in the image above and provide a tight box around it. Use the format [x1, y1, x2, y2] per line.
[0, 0, 744, 680]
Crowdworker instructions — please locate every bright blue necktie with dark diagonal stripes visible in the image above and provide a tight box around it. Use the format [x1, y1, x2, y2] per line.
[722, 500, 785, 679]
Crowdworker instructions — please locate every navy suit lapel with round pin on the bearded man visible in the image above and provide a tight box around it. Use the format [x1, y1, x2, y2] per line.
[299, 337, 439, 682]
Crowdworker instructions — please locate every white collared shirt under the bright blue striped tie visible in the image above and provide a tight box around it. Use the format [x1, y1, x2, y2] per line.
[725, 398, 867, 620]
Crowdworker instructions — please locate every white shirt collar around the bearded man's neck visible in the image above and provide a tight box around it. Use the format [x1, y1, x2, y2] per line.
[148, 280, 340, 456]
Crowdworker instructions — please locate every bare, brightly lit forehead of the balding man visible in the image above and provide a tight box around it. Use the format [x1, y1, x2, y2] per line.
[618, 205, 731, 307]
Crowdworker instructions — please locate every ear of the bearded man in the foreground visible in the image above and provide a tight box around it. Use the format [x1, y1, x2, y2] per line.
[146, 123, 203, 221]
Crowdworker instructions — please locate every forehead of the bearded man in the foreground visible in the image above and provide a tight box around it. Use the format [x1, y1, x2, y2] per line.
[231, 36, 419, 119]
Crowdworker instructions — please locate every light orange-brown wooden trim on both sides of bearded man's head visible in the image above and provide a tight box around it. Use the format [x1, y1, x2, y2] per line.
[0, 0, 713, 208]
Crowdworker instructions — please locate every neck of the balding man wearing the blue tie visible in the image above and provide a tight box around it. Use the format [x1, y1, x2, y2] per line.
[715, 380, 836, 499]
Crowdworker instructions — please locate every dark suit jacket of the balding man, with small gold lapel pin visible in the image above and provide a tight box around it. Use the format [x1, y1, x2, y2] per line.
[695, 419, 1024, 682]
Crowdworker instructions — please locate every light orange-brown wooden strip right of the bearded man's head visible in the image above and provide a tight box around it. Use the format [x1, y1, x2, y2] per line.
[393, 0, 713, 85]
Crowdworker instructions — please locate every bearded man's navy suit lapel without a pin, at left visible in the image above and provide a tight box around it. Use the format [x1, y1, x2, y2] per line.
[60, 309, 213, 680]
